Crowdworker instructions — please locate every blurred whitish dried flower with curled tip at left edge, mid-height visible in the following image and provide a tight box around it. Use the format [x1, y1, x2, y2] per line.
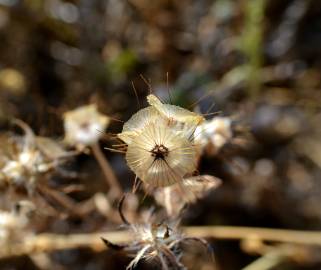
[0, 120, 72, 192]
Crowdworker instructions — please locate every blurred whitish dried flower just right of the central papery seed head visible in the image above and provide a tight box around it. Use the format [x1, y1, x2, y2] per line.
[195, 117, 233, 155]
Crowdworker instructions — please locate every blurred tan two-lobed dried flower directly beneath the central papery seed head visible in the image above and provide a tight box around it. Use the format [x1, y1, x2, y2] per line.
[154, 175, 222, 217]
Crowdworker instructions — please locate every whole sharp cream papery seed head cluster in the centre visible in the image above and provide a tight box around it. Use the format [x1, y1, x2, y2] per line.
[118, 95, 204, 187]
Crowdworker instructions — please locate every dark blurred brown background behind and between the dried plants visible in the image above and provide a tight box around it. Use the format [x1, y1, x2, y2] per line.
[0, 0, 321, 270]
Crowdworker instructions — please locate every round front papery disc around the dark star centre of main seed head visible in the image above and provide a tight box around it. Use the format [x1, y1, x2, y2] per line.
[126, 119, 197, 186]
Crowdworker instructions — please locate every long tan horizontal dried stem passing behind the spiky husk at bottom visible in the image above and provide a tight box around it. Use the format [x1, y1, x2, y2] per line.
[0, 226, 321, 259]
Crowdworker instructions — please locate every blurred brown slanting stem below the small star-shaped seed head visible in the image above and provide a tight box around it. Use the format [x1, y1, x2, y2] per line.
[91, 143, 123, 197]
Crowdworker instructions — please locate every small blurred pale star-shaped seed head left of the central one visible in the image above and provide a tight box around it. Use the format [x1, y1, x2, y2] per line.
[64, 104, 110, 148]
